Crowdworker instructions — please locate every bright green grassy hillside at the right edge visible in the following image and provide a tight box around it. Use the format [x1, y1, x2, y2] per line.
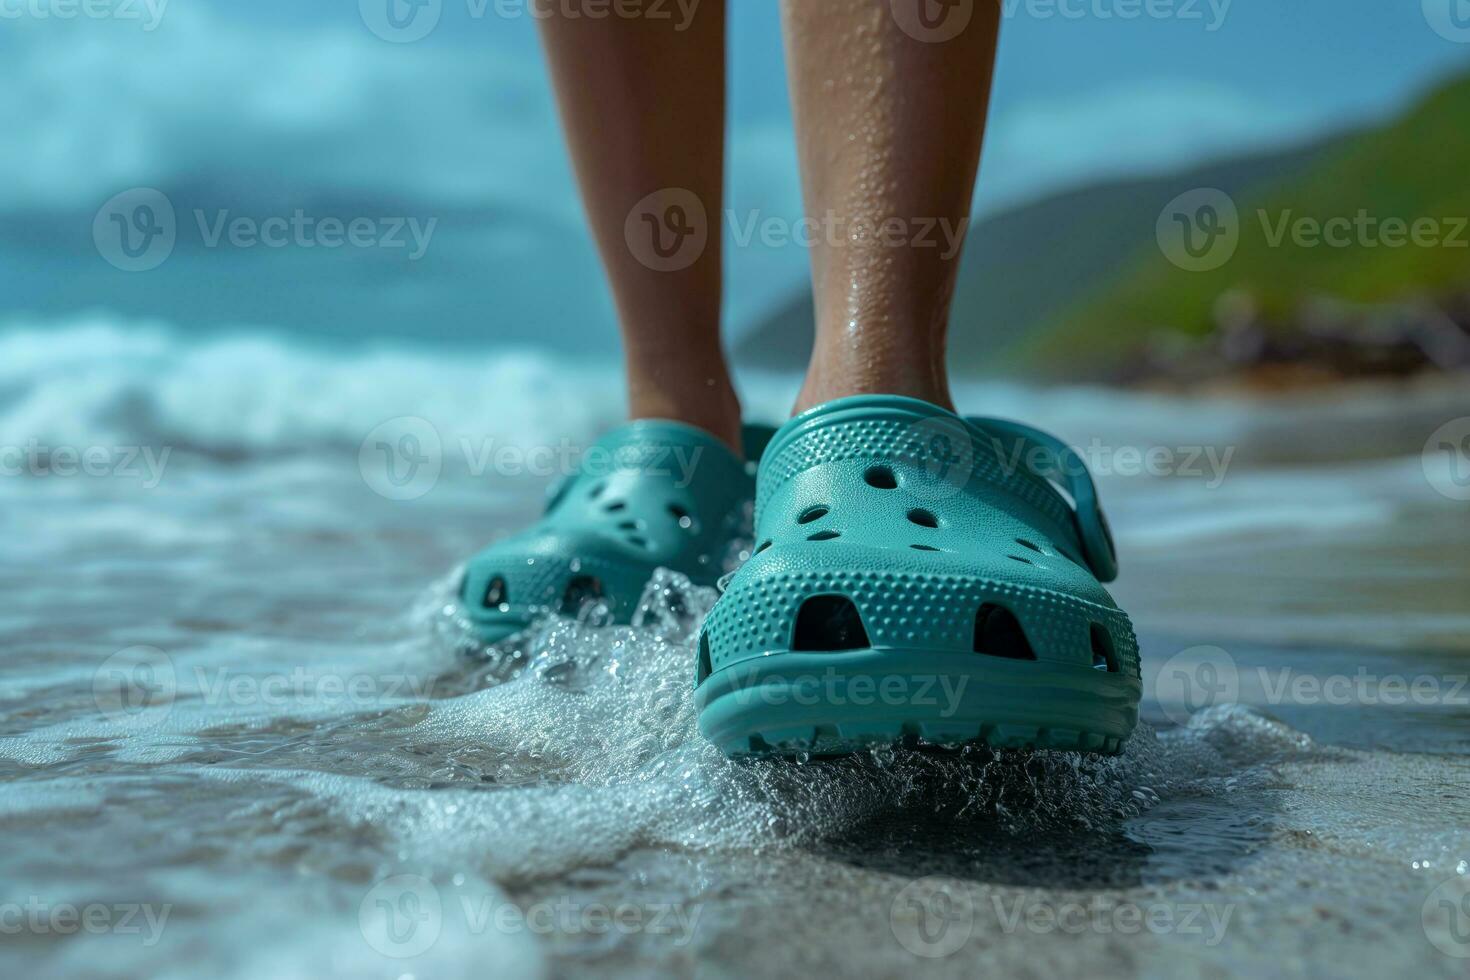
[1025, 71, 1470, 375]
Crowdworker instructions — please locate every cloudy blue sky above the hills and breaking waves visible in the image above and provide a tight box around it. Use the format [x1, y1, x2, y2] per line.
[0, 0, 1470, 351]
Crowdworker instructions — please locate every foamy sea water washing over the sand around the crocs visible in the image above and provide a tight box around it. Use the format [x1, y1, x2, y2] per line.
[0, 317, 1470, 977]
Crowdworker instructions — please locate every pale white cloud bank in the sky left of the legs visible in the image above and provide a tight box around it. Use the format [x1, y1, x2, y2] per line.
[0, 3, 576, 215]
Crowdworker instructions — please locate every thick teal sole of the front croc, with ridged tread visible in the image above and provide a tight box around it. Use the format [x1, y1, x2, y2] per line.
[694, 649, 1141, 757]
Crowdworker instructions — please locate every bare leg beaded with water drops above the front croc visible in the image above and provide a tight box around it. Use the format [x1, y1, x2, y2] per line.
[782, 0, 1000, 411]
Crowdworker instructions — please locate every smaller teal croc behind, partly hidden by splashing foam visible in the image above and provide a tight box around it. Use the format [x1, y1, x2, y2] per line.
[460, 420, 769, 644]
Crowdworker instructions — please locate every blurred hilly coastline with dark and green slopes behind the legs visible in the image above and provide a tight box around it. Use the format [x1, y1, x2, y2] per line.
[736, 75, 1470, 394]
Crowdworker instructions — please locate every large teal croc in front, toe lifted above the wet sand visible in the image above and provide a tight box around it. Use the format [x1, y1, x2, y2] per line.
[695, 395, 1141, 755]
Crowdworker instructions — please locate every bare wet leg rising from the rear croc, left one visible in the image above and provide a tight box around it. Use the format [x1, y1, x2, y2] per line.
[542, 0, 739, 451]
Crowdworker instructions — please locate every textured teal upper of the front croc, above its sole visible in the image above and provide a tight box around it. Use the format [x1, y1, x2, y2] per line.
[697, 395, 1138, 746]
